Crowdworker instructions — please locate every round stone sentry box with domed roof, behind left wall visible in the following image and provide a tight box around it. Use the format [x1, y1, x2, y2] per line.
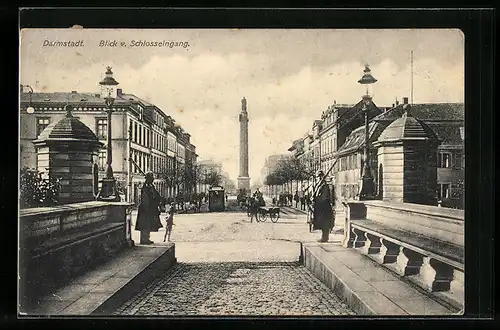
[33, 106, 102, 204]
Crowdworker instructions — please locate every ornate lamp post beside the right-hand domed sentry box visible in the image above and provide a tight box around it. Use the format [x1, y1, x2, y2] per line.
[358, 64, 377, 199]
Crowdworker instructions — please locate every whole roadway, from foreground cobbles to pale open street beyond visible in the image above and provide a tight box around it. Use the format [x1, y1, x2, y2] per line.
[116, 201, 354, 315]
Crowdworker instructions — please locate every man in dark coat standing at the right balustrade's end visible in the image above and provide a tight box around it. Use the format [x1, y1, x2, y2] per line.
[313, 171, 333, 243]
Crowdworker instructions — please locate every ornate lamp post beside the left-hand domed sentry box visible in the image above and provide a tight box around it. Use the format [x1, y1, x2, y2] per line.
[97, 66, 120, 201]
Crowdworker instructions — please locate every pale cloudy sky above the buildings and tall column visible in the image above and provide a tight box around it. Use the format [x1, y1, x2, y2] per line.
[20, 28, 464, 184]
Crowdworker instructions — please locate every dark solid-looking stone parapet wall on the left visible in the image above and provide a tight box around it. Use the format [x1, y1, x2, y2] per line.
[19, 201, 133, 305]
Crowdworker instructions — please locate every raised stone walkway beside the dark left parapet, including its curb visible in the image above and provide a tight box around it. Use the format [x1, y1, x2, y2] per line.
[20, 243, 176, 316]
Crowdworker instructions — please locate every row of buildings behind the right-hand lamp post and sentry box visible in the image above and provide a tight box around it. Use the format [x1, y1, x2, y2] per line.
[288, 98, 465, 211]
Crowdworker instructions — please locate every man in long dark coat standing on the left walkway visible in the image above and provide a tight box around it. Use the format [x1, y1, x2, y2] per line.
[135, 172, 162, 244]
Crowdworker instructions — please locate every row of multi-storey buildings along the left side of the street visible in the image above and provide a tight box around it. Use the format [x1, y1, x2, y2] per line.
[20, 68, 197, 202]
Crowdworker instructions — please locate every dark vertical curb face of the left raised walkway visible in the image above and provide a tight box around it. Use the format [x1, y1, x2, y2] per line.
[90, 244, 177, 316]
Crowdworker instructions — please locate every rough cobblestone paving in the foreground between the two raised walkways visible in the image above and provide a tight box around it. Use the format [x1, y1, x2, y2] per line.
[114, 262, 355, 316]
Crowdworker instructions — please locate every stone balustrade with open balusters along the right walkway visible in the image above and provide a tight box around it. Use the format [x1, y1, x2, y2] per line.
[343, 201, 464, 309]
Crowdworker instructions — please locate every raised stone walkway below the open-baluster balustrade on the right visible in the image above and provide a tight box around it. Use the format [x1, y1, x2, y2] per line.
[301, 243, 456, 315]
